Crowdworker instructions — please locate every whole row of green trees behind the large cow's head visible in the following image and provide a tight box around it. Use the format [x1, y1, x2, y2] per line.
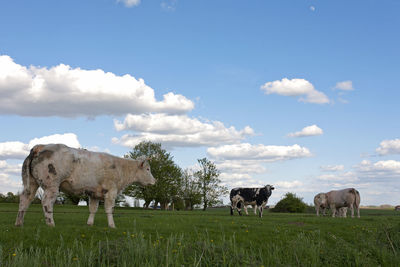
[123, 141, 228, 210]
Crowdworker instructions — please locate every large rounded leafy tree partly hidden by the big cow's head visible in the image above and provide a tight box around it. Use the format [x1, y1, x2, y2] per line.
[124, 141, 182, 209]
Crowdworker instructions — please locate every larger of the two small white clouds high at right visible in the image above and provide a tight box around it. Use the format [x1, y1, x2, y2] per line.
[261, 78, 330, 104]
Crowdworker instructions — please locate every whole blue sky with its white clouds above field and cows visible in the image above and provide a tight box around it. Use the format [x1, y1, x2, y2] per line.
[0, 0, 400, 205]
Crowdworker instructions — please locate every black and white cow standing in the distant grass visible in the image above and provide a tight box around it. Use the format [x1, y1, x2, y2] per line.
[230, 185, 275, 217]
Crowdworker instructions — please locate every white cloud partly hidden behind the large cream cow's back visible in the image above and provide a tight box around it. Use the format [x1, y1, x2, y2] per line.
[0, 133, 81, 159]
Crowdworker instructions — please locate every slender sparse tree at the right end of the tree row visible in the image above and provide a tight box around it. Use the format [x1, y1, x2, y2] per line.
[195, 158, 228, 210]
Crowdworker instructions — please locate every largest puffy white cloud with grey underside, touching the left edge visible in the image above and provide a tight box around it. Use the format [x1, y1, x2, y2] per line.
[0, 56, 194, 117]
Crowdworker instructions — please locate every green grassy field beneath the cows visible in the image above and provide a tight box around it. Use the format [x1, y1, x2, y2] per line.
[0, 204, 400, 266]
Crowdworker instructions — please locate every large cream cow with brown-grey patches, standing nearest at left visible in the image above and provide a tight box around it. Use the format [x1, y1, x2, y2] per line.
[15, 144, 156, 228]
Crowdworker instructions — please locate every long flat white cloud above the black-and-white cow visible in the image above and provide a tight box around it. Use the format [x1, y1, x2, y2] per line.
[207, 143, 311, 162]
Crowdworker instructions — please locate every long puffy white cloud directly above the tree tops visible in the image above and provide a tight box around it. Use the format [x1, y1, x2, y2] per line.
[112, 113, 254, 148]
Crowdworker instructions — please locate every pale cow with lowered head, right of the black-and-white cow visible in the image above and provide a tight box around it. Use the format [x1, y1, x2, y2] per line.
[314, 188, 360, 218]
